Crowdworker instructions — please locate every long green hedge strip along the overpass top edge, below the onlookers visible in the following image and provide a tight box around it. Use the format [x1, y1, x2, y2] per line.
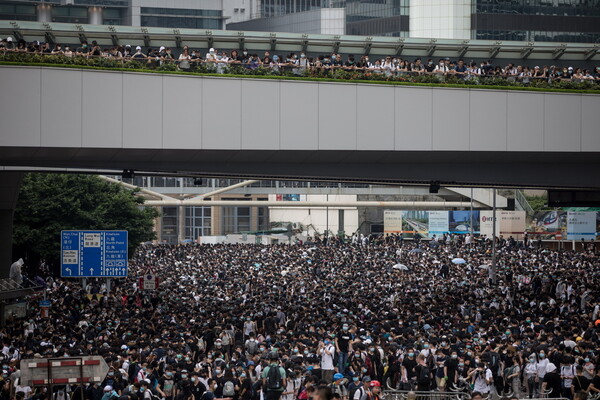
[0, 53, 600, 94]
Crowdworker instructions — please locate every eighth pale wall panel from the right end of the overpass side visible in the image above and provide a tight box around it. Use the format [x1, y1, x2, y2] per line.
[319, 83, 356, 150]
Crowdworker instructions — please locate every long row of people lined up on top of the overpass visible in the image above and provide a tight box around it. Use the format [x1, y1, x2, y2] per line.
[0, 37, 600, 86]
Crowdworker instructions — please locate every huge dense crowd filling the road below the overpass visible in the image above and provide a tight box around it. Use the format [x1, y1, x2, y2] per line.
[0, 236, 600, 400]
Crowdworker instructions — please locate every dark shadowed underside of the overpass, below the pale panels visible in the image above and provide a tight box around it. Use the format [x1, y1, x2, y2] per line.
[0, 148, 600, 188]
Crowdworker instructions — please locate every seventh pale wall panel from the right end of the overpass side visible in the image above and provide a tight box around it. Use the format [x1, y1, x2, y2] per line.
[356, 85, 394, 151]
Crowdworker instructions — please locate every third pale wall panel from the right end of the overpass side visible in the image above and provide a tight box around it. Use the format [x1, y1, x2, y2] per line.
[507, 91, 544, 151]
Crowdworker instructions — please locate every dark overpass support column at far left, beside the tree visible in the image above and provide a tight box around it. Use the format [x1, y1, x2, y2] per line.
[0, 172, 24, 278]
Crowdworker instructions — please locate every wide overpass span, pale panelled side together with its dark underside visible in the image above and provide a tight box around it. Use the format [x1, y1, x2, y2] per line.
[0, 66, 600, 188]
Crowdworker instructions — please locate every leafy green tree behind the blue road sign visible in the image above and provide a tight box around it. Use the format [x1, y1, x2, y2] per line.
[13, 174, 158, 274]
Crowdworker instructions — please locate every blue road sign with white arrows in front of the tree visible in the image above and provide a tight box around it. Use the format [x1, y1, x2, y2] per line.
[60, 231, 128, 278]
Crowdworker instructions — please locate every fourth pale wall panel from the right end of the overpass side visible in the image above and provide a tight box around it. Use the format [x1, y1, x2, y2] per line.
[469, 90, 507, 151]
